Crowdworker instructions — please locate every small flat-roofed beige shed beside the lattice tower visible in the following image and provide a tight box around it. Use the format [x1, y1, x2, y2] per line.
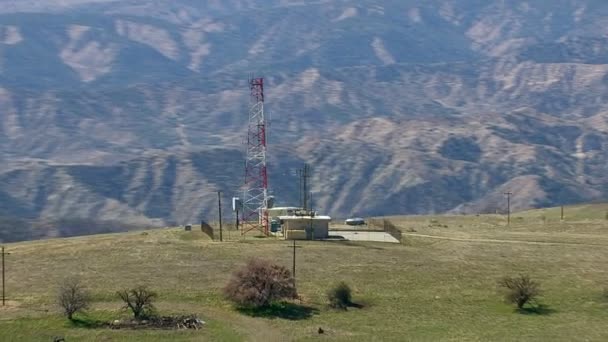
[279, 216, 331, 240]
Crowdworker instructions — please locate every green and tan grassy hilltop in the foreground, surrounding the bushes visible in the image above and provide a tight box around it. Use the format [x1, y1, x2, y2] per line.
[0, 207, 608, 341]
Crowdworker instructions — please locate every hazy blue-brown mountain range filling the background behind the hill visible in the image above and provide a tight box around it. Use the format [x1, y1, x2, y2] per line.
[0, 0, 608, 239]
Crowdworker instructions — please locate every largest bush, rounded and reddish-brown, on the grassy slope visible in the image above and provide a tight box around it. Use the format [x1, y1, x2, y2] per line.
[224, 259, 297, 308]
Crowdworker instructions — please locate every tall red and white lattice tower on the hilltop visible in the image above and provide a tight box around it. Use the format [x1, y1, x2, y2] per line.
[241, 78, 268, 235]
